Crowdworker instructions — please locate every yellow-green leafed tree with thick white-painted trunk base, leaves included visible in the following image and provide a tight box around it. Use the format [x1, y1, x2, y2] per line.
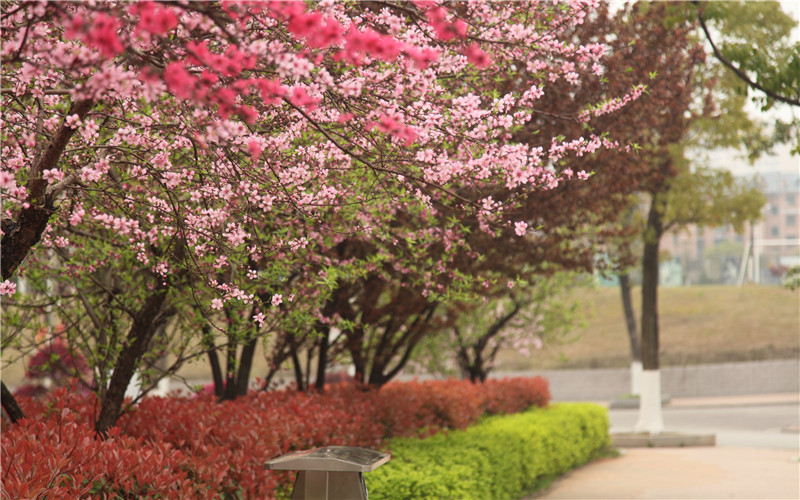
[616, 0, 784, 433]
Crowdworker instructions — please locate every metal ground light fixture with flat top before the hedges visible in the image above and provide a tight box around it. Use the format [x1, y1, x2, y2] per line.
[264, 446, 391, 500]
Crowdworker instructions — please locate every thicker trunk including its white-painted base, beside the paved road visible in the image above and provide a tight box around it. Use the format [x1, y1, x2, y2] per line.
[635, 193, 666, 434]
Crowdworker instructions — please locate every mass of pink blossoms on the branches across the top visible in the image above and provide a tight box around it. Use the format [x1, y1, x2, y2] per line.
[0, 0, 639, 314]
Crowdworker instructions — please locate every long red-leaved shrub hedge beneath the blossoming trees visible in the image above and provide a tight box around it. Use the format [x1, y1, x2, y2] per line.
[2, 377, 550, 498]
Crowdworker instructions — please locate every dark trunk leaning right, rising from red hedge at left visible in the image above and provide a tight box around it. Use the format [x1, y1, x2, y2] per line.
[95, 288, 167, 438]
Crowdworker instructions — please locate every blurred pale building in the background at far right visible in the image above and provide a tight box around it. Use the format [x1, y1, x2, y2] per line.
[661, 167, 800, 285]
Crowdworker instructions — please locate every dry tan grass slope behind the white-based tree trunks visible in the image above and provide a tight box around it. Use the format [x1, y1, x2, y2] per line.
[498, 285, 800, 370]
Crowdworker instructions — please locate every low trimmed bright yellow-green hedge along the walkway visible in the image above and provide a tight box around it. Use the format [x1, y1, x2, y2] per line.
[365, 403, 609, 500]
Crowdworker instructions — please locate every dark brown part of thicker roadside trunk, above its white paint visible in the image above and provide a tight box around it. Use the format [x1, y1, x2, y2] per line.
[642, 193, 665, 370]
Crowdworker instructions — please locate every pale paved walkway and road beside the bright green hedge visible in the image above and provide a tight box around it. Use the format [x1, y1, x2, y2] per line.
[537, 394, 800, 500]
